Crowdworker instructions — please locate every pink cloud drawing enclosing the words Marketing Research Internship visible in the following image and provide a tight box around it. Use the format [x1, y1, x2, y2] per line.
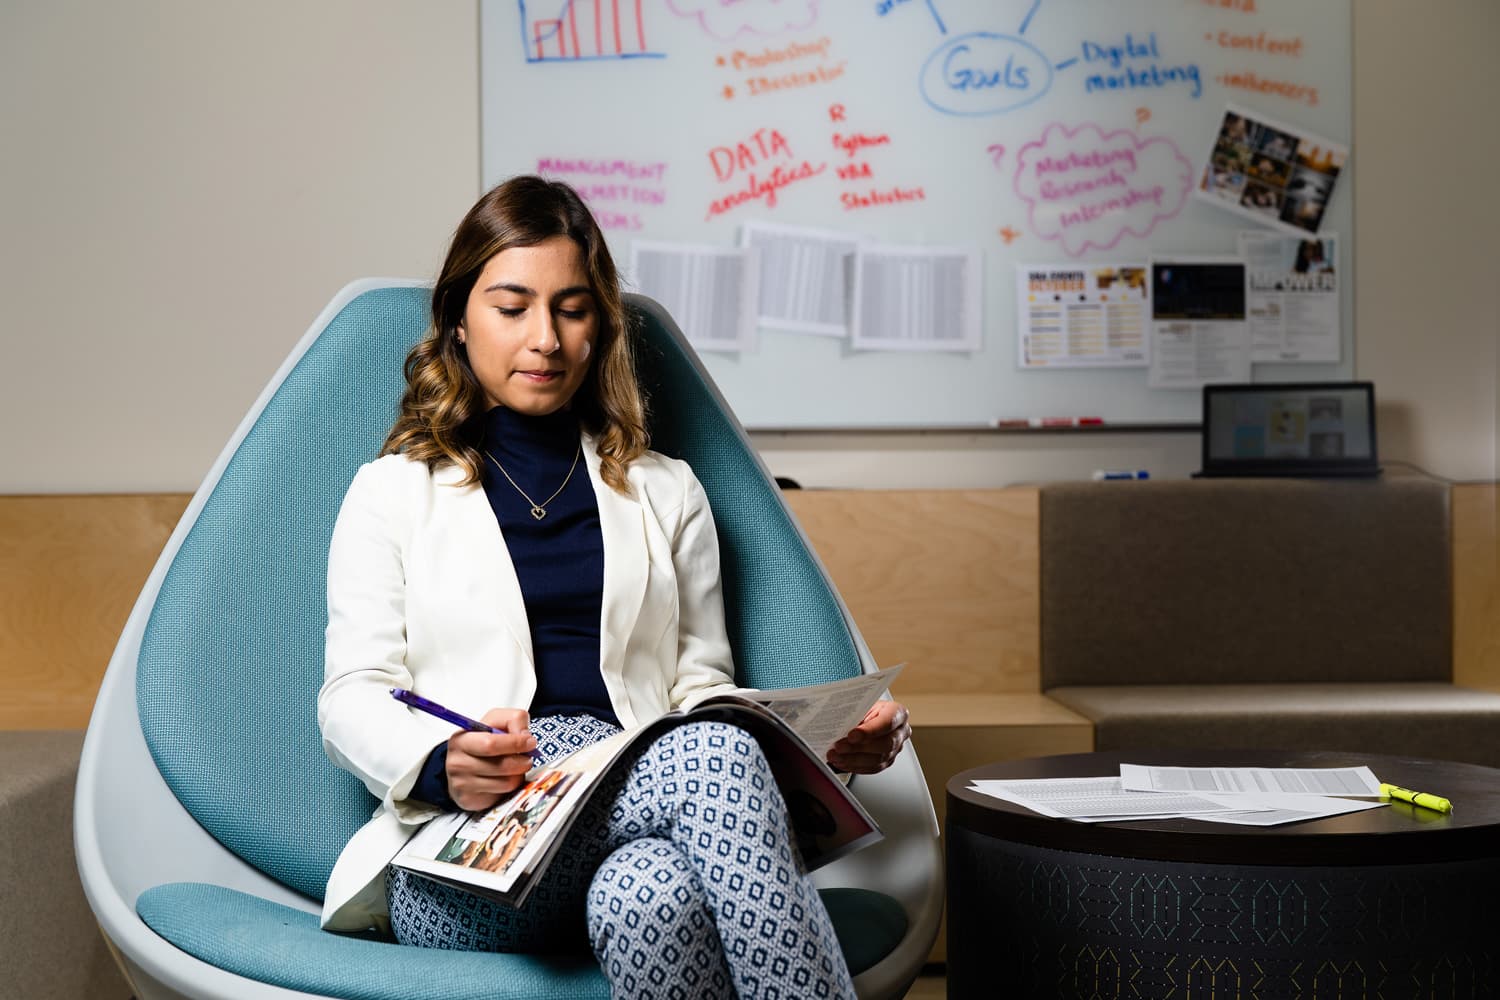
[1016, 121, 1193, 256]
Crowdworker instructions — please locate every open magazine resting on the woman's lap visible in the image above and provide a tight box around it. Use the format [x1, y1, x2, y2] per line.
[392, 666, 902, 907]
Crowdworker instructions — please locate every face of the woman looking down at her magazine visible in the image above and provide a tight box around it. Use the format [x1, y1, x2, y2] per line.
[459, 235, 599, 417]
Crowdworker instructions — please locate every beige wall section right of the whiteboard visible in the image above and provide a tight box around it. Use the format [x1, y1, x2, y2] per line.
[1352, 0, 1500, 480]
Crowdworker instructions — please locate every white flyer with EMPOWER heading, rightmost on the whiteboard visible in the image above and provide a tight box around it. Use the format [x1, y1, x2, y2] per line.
[1239, 231, 1341, 363]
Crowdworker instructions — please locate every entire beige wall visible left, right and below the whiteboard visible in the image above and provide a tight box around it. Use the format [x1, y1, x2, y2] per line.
[0, 0, 1500, 493]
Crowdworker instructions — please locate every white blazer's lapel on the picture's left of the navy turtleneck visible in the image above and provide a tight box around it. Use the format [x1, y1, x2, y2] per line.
[434, 465, 537, 670]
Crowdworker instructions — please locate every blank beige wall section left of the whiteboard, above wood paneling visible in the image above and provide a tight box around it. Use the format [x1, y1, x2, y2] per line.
[0, 0, 479, 493]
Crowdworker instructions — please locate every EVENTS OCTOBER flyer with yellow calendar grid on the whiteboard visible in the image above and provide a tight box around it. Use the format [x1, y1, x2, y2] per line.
[1016, 262, 1151, 369]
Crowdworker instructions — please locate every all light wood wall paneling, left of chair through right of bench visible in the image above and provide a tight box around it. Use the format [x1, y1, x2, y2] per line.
[0, 484, 1500, 729]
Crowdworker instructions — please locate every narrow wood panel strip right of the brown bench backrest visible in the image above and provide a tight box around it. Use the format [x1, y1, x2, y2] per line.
[1452, 483, 1500, 691]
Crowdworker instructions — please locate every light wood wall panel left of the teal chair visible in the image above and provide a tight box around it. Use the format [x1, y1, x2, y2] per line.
[0, 493, 189, 730]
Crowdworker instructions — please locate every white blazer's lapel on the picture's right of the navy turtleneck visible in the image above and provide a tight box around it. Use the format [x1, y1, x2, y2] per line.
[584, 435, 648, 687]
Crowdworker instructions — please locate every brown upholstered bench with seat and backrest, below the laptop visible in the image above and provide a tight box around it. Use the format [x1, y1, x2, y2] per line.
[1041, 477, 1500, 768]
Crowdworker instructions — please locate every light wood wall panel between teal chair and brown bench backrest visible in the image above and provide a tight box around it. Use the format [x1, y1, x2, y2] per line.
[786, 489, 1040, 696]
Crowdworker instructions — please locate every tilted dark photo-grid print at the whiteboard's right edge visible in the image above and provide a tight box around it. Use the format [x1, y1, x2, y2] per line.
[1193, 105, 1349, 235]
